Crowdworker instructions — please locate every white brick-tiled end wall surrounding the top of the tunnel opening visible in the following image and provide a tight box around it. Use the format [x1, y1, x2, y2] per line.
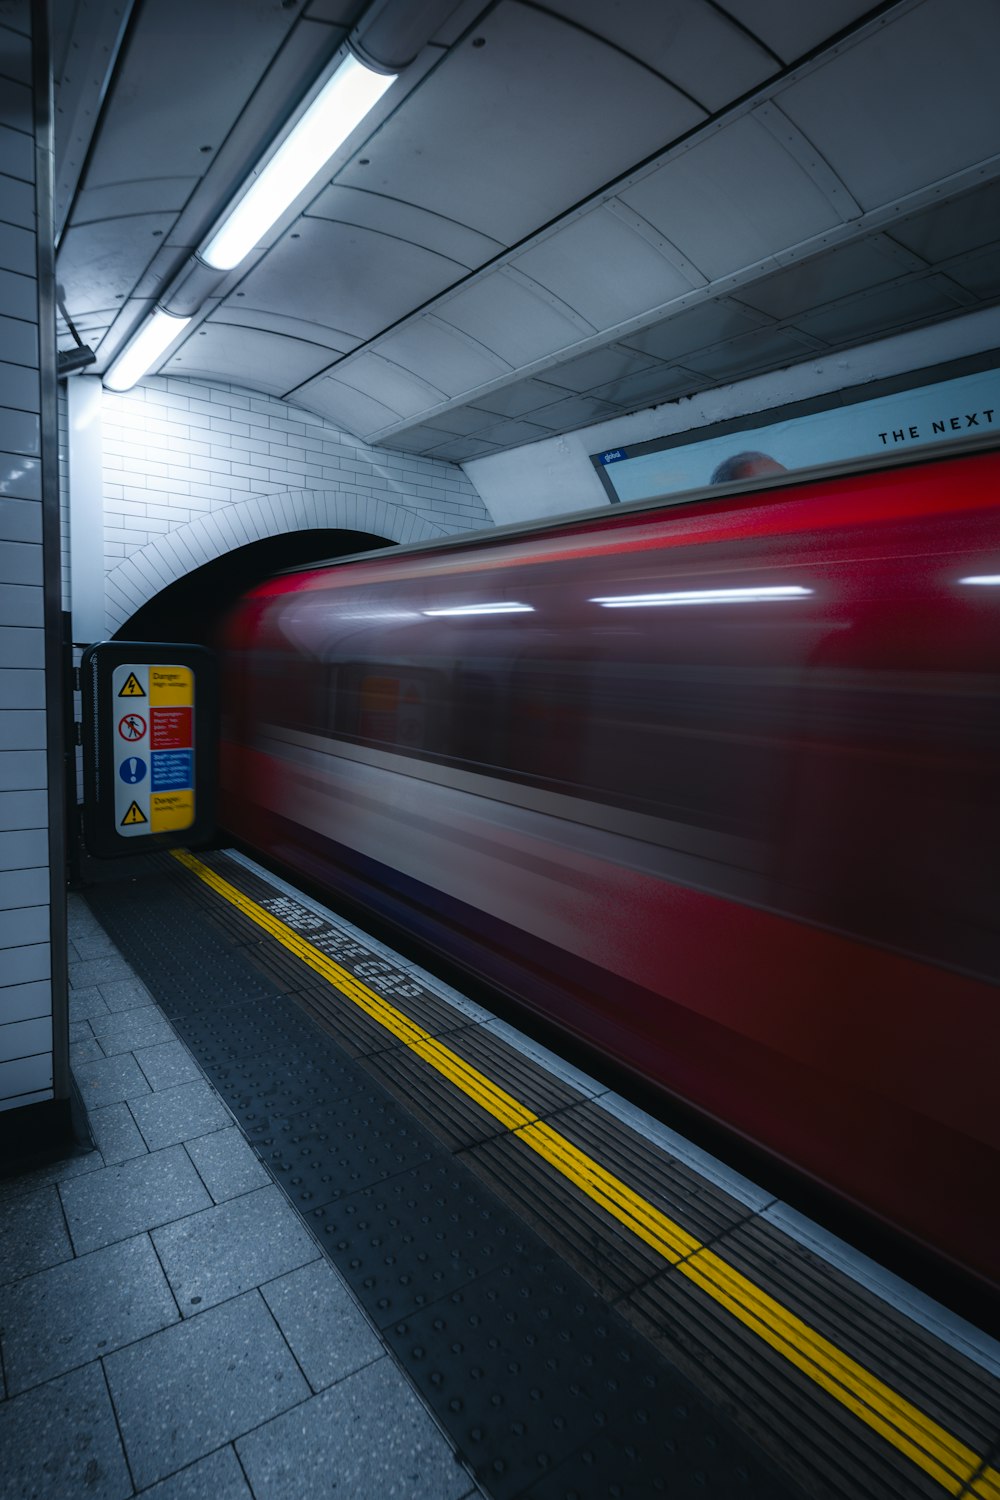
[95, 377, 492, 630]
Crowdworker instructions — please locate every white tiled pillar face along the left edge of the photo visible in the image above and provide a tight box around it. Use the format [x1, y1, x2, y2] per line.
[0, 6, 52, 1110]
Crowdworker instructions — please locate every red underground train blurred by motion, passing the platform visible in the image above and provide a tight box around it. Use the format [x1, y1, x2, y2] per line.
[222, 452, 1000, 1286]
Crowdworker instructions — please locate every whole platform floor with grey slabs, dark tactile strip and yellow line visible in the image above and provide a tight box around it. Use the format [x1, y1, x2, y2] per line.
[0, 855, 1000, 1500]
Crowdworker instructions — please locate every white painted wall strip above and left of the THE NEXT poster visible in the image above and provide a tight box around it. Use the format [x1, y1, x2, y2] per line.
[463, 308, 1000, 527]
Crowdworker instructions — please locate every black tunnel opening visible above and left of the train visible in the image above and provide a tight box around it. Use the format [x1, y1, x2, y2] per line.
[112, 528, 396, 645]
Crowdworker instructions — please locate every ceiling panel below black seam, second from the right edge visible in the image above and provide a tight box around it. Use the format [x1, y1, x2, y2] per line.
[619, 116, 841, 281]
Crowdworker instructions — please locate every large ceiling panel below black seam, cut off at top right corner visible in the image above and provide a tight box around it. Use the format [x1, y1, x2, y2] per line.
[777, 0, 1000, 210]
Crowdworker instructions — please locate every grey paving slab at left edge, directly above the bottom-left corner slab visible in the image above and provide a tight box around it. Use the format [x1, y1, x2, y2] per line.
[0, 1235, 178, 1392]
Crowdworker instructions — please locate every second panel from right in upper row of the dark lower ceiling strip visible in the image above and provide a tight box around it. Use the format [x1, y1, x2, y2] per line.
[733, 236, 924, 321]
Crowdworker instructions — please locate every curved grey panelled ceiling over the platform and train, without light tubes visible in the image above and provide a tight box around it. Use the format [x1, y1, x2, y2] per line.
[56, 0, 1000, 459]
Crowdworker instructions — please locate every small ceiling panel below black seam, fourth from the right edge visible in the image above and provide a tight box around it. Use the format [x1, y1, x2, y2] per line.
[438, 275, 594, 368]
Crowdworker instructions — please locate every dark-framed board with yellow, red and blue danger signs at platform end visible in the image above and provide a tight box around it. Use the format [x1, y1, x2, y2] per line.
[81, 641, 217, 858]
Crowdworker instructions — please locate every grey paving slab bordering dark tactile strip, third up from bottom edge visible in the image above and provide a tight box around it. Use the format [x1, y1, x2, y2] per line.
[153, 1187, 318, 1317]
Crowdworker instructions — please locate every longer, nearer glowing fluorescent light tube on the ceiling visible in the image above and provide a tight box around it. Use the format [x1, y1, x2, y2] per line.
[201, 56, 397, 272]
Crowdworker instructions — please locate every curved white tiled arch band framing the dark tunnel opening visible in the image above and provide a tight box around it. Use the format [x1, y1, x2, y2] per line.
[105, 489, 448, 636]
